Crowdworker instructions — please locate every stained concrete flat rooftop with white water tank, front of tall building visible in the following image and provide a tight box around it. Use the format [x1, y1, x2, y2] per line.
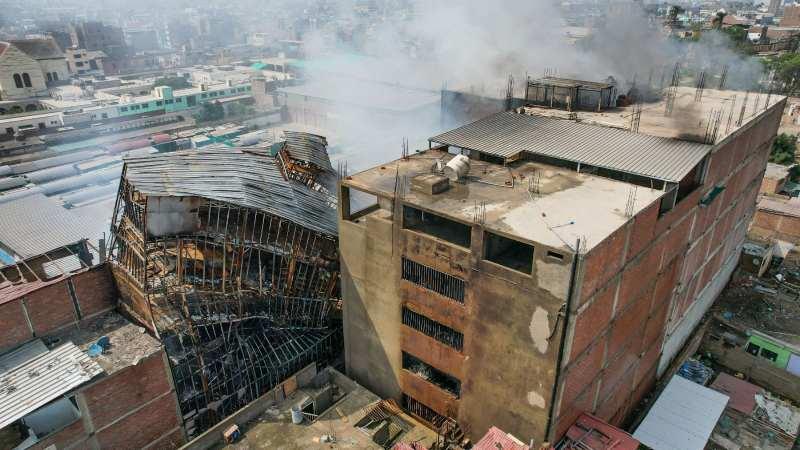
[344, 149, 664, 251]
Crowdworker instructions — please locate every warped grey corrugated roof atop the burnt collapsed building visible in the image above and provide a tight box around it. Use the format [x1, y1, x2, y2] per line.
[125, 148, 338, 235]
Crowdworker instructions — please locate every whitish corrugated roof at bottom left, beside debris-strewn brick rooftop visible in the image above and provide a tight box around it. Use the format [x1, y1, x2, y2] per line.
[0, 342, 103, 429]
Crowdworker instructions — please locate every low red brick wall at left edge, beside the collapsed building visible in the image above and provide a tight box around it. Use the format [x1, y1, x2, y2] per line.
[0, 265, 117, 352]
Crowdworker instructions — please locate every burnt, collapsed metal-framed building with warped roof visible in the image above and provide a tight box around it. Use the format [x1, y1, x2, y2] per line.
[110, 134, 342, 436]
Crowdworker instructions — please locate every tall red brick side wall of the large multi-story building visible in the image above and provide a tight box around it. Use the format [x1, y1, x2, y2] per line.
[555, 104, 784, 437]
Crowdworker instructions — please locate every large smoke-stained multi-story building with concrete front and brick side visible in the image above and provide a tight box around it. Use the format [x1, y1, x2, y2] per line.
[339, 88, 785, 443]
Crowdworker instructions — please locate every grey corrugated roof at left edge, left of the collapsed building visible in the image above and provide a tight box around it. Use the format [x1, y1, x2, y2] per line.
[0, 193, 87, 259]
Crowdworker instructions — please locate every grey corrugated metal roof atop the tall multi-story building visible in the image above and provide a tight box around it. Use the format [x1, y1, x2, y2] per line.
[430, 112, 711, 183]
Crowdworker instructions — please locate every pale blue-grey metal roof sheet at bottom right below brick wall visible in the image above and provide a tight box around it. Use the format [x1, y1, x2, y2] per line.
[633, 375, 728, 450]
